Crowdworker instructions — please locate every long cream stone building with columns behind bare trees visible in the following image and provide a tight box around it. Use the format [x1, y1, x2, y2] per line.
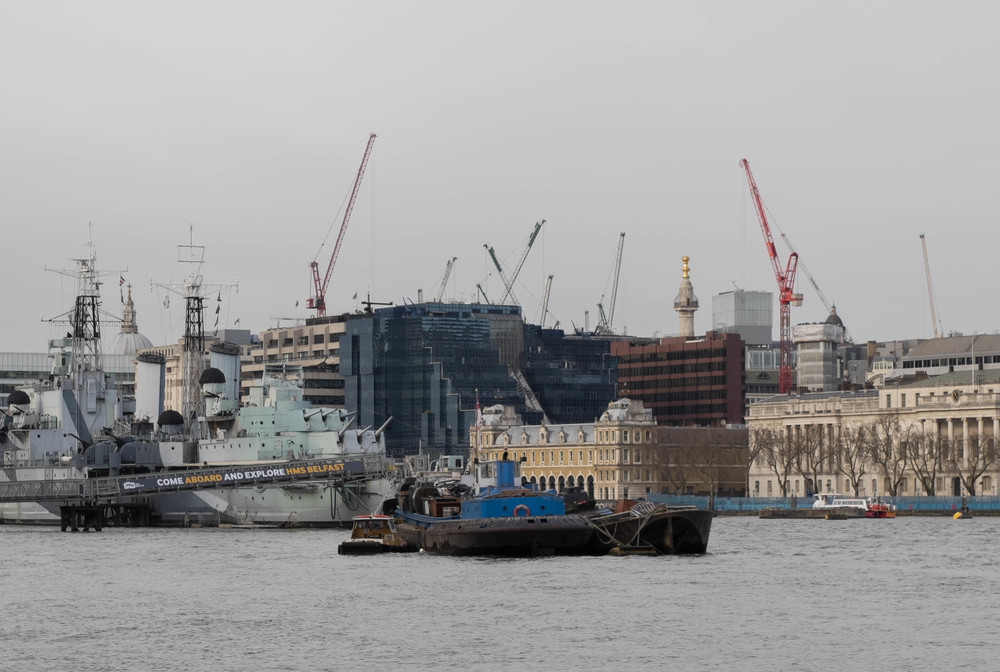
[747, 368, 1000, 497]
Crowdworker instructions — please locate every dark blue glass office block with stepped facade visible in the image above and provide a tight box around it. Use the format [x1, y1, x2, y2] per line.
[340, 302, 616, 455]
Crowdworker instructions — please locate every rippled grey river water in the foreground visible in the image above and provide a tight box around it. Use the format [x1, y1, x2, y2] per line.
[0, 517, 1000, 672]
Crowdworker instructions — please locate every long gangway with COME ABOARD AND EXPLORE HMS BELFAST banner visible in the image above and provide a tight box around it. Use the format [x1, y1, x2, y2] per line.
[0, 454, 387, 503]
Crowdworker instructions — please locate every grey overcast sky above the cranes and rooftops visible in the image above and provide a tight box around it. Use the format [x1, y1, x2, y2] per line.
[0, 0, 1000, 352]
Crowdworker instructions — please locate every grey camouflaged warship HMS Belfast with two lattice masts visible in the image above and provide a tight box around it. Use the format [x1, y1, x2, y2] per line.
[0, 239, 394, 526]
